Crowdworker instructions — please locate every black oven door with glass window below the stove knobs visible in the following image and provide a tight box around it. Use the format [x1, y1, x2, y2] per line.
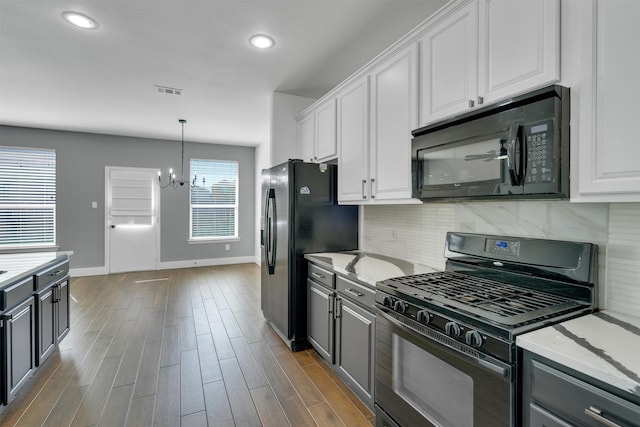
[375, 305, 515, 427]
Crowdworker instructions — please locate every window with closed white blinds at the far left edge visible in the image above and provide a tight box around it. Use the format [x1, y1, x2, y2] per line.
[0, 147, 56, 249]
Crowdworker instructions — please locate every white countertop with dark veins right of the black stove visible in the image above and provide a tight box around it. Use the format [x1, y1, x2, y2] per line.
[516, 310, 640, 397]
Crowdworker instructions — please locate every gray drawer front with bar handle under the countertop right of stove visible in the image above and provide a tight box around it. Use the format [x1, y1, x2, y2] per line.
[531, 360, 640, 426]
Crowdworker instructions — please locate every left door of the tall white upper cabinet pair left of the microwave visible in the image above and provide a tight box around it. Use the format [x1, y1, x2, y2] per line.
[337, 76, 369, 202]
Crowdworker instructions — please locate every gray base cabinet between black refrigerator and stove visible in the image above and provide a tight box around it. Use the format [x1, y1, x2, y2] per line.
[307, 263, 375, 408]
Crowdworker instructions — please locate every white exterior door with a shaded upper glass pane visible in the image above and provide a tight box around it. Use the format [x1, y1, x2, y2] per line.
[105, 166, 160, 273]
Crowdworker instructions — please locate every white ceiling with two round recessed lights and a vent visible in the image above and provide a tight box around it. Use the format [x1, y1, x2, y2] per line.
[0, 0, 445, 145]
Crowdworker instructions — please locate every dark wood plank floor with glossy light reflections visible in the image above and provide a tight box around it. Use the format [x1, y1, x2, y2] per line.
[0, 264, 374, 427]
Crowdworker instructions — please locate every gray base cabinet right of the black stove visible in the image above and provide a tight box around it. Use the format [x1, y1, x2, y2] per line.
[522, 351, 640, 427]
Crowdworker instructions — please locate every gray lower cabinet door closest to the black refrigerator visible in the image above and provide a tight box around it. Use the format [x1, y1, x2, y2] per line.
[307, 280, 335, 363]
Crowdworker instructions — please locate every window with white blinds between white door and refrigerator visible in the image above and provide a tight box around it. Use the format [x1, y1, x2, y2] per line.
[189, 159, 238, 240]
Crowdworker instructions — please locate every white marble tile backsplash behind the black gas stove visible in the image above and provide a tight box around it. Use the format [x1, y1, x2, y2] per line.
[362, 201, 640, 316]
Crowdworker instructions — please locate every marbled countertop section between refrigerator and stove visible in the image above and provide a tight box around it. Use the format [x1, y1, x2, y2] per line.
[304, 251, 437, 287]
